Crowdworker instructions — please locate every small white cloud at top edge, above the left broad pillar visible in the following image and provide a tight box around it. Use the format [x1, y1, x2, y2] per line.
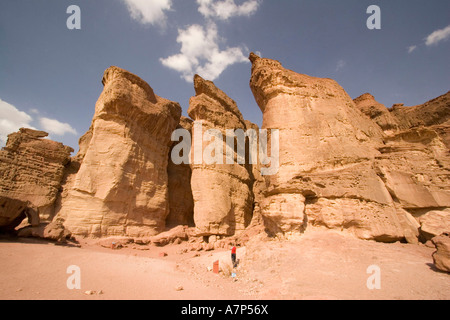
[123, 0, 172, 27]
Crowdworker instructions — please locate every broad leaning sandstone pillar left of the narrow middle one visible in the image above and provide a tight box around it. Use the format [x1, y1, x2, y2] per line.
[58, 67, 181, 237]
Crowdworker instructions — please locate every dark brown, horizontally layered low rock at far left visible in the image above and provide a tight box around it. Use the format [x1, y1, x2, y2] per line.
[0, 128, 73, 229]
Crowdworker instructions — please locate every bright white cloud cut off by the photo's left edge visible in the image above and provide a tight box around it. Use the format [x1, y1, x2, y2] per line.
[0, 99, 34, 145]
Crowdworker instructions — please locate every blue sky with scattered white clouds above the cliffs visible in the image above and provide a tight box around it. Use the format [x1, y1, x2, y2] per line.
[0, 0, 450, 150]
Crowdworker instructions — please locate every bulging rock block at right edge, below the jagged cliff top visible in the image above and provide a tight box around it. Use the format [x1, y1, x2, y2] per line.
[376, 128, 450, 210]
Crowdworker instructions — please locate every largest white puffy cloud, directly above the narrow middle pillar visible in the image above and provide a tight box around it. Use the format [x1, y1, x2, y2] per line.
[160, 22, 248, 82]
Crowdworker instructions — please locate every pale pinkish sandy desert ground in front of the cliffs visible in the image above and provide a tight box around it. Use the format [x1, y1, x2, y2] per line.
[0, 231, 450, 300]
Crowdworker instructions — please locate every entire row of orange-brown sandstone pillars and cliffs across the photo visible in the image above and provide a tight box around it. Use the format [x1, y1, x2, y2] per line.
[0, 58, 450, 246]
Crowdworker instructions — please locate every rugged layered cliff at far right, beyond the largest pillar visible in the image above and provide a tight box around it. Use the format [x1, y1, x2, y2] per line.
[355, 93, 450, 241]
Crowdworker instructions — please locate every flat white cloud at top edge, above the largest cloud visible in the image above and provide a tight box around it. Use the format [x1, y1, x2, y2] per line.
[197, 0, 260, 20]
